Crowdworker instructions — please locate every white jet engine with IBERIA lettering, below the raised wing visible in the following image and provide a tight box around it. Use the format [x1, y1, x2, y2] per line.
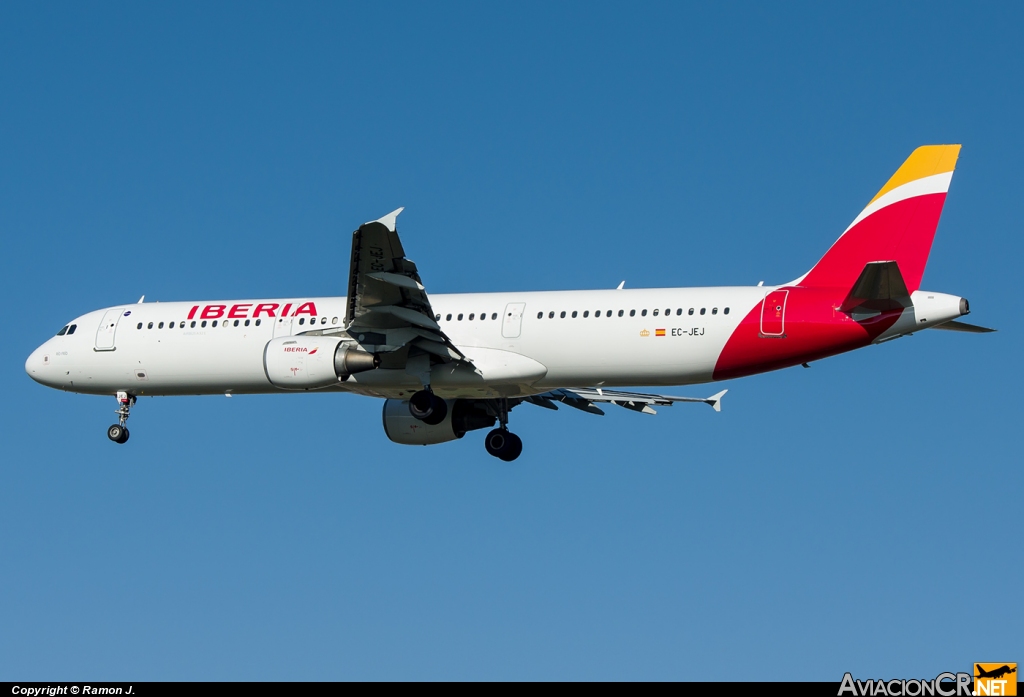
[263, 336, 380, 390]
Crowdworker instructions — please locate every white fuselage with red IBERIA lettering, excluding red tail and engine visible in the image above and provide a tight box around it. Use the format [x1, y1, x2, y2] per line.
[26, 287, 769, 397]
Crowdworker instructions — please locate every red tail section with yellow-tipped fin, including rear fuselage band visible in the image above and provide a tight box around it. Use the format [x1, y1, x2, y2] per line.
[714, 145, 959, 380]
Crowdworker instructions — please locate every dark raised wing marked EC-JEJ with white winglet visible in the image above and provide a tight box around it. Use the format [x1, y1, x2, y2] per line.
[345, 208, 464, 366]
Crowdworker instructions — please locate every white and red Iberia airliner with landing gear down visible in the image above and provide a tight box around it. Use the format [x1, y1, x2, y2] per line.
[25, 145, 993, 462]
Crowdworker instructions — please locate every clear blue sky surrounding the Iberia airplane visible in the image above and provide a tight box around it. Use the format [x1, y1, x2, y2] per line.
[0, 2, 1024, 681]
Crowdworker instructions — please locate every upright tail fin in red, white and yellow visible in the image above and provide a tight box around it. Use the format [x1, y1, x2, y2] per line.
[793, 145, 961, 293]
